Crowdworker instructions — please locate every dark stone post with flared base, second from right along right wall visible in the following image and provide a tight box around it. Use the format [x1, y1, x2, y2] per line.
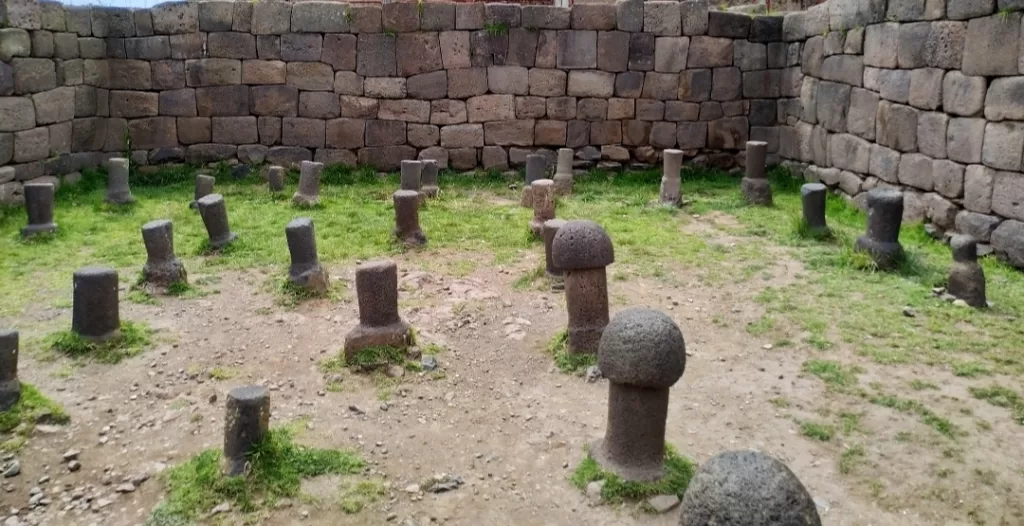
[854, 188, 903, 270]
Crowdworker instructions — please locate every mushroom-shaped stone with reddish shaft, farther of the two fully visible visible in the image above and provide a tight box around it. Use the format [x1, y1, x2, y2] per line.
[551, 221, 615, 354]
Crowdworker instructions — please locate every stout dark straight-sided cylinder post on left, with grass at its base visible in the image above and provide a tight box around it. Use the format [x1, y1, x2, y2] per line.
[71, 267, 121, 342]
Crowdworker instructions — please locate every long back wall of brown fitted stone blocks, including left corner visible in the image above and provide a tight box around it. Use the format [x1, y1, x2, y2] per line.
[0, 0, 800, 195]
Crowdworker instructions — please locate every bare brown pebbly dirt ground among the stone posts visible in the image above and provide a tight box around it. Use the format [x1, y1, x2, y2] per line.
[0, 210, 1021, 526]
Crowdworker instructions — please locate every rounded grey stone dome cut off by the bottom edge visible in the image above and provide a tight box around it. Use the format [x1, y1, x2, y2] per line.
[679, 448, 821, 526]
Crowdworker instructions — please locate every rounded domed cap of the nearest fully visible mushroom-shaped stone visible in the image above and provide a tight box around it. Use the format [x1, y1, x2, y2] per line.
[597, 307, 686, 389]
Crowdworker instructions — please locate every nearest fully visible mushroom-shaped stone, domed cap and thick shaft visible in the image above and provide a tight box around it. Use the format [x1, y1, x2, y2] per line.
[590, 308, 686, 482]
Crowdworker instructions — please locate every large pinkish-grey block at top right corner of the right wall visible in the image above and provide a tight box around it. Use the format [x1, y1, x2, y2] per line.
[962, 12, 1021, 76]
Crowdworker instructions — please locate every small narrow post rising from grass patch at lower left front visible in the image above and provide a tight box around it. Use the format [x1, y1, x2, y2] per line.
[224, 386, 270, 477]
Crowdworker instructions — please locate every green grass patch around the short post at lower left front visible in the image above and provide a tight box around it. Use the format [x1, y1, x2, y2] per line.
[145, 429, 365, 526]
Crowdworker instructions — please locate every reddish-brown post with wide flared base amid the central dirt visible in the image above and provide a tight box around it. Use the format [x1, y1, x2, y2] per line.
[345, 261, 413, 361]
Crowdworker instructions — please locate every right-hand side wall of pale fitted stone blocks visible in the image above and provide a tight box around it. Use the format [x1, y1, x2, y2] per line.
[779, 0, 1024, 267]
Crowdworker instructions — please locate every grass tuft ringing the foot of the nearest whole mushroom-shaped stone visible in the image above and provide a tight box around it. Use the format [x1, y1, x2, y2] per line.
[569, 445, 696, 511]
